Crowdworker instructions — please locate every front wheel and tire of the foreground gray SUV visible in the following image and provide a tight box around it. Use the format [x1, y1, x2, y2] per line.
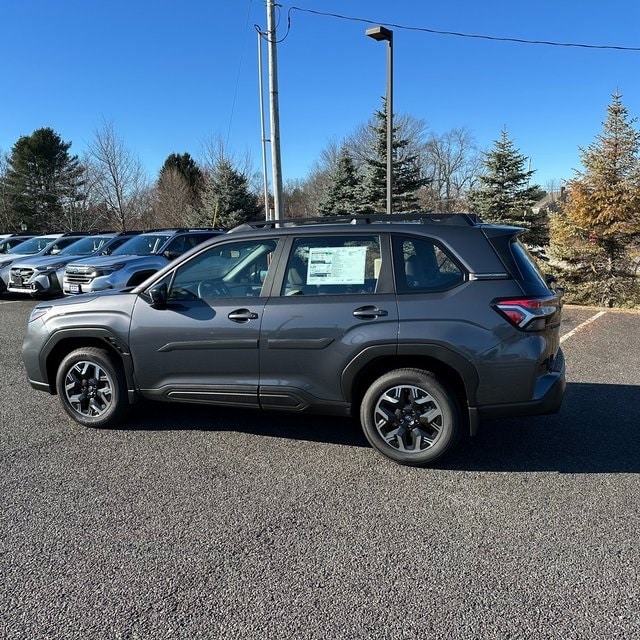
[56, 347, 129, 427]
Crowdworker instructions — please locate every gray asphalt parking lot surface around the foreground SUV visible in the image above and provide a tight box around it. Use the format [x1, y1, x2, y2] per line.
[0, 298, 640, 640]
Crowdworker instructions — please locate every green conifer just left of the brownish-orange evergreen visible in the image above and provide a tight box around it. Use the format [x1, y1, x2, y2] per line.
[469, 130, 548, 246]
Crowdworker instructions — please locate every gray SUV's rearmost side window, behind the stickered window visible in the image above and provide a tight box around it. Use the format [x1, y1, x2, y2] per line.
[393, 236, 465, 293]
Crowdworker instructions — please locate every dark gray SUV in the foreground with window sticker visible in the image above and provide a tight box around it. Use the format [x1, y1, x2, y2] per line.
[23, 214, 565, 466]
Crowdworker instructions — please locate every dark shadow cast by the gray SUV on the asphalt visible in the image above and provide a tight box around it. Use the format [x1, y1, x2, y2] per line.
[125, 383, 640, 473]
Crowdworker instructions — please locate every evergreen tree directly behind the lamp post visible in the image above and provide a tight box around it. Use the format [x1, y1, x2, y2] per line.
[364, 100, 426, 212]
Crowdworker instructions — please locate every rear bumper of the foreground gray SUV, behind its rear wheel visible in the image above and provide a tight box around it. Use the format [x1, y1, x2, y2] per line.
[478, 350, 567, 419]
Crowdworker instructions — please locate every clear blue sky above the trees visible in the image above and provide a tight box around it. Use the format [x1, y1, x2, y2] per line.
[0, 0, 640, 187]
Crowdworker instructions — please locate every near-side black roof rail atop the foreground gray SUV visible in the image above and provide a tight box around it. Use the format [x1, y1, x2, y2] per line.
[231, 212, 482, 231]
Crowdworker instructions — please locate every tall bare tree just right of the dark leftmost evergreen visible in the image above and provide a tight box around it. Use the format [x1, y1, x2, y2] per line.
[88, 122, 150, 231]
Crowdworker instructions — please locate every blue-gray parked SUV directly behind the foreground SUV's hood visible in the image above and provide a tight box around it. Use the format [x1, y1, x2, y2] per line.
[62, 229, 223, 295]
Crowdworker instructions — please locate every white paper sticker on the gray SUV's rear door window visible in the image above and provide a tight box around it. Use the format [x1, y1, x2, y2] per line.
[307, 247, 367, 284]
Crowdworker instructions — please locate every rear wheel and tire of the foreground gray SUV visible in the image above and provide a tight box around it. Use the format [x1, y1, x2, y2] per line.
[360, 369, 460, 467]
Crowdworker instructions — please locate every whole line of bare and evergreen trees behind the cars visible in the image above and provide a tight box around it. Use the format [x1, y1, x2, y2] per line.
[0, 92, 640, 306]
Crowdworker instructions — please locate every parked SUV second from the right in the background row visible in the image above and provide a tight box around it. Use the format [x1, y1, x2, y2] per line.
[7, 231, 139, 297]
